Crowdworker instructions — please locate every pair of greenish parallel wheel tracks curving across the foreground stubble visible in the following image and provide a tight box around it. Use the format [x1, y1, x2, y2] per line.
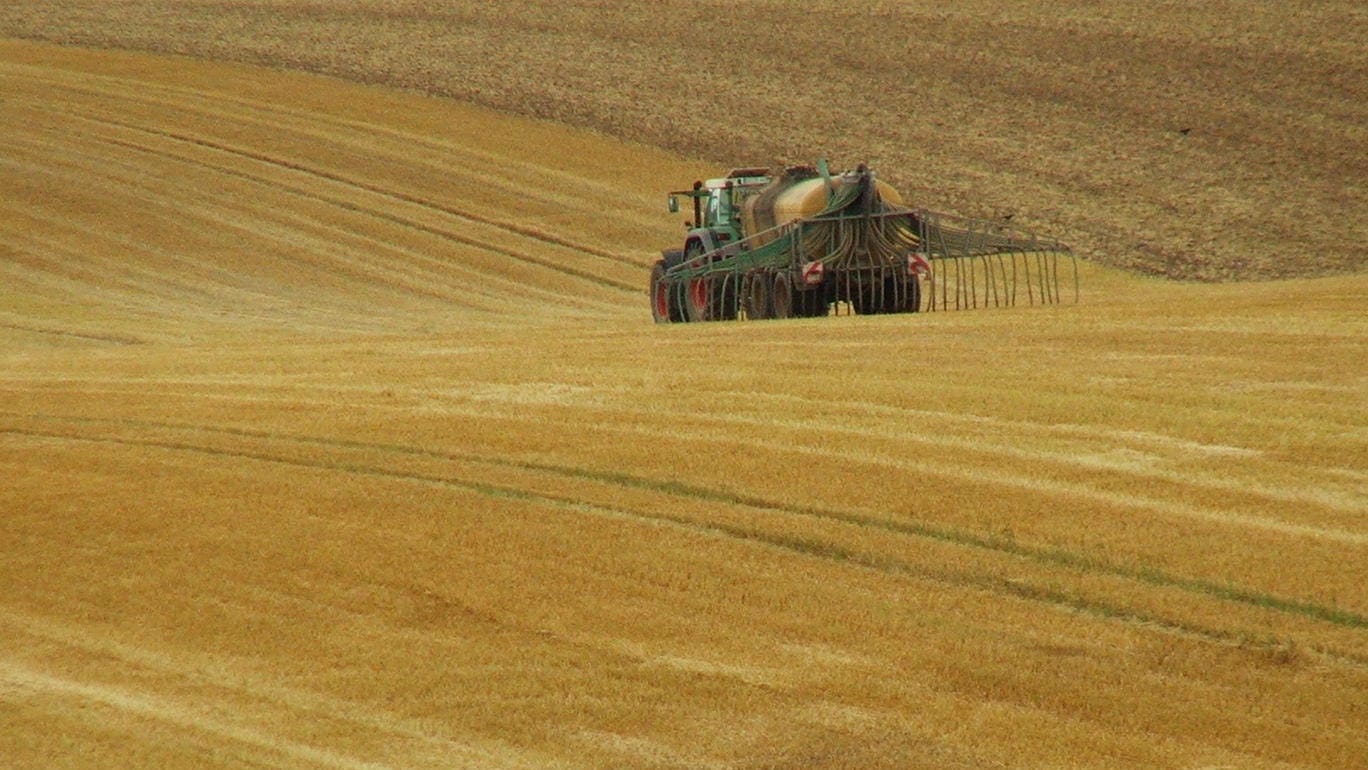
[0, 412, 1368, 670]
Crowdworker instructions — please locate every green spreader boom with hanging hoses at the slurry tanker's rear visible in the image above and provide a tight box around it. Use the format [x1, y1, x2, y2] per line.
[661, 170, 1079, 320]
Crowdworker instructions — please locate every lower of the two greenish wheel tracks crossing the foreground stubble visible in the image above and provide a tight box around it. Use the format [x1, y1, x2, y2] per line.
[0, 428, 1368, 670]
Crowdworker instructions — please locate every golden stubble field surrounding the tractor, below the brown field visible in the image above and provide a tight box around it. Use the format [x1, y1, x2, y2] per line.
[0, 42, 1368, 770]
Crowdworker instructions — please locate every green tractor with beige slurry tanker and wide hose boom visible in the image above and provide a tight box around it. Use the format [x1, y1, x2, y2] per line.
[650, 161, 1078, 323]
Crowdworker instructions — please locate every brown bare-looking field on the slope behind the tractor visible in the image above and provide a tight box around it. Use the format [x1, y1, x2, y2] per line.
[0, 0, 1368, 280]
